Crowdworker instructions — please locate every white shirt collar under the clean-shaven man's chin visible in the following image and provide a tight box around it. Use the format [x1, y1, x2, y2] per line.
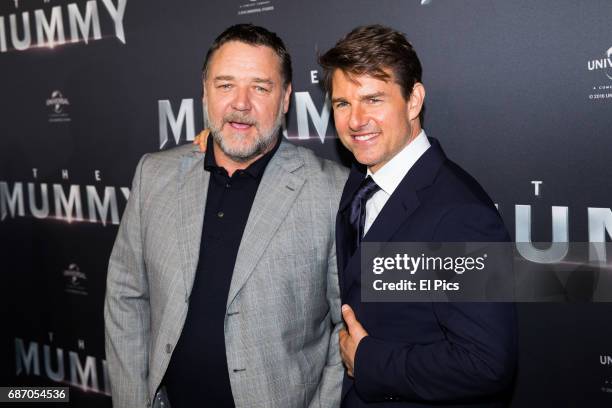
[367, 130, 431, 195]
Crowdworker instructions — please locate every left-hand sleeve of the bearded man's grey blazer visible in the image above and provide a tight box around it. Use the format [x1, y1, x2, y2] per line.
[104, 155, 150, 408]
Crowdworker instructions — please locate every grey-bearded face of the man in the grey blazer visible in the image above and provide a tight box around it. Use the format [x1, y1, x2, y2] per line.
[203, 41, 291, 164]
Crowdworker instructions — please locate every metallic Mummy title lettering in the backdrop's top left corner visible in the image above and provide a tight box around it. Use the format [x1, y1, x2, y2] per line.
[0, 0, 127, 53]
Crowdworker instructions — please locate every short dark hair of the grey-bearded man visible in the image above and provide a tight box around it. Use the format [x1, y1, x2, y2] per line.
[202, 24, 292, 88]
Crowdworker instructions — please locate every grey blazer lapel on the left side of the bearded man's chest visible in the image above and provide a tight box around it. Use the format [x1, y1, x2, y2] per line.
[178, 147, 210, 297]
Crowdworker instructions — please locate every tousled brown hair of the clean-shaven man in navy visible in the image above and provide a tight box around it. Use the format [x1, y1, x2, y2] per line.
[319, 24, 423, 121]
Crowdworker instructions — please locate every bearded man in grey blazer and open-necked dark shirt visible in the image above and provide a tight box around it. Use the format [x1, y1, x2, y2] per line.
[104, 24, 347, 408]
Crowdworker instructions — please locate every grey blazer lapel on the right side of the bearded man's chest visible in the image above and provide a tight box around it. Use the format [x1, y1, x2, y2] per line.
[227, 142, 306, 307]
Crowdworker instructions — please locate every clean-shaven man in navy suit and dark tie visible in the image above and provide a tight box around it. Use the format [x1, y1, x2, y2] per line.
[320, 25, 517, 407]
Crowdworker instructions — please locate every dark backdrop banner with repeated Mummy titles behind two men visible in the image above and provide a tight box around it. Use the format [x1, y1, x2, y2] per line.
[0, 0, 612, 407]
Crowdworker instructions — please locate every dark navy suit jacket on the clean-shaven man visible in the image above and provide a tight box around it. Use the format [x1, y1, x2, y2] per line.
[336, 138, 517, 408]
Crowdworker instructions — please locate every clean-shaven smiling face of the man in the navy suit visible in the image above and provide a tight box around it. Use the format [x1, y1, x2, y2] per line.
[332, 69, 425, 173]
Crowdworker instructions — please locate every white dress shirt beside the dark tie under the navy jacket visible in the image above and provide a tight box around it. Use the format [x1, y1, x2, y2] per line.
[363, 130, 431, 235]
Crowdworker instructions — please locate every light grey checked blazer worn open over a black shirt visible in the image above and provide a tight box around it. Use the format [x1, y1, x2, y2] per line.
[104, 141, 348, 408]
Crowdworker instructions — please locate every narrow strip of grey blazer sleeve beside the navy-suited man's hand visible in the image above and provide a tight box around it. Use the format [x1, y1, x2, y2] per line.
[308, 240, 344, 408]
